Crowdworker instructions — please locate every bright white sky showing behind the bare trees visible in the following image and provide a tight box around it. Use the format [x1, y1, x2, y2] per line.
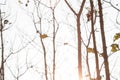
[0, 0, 120, 80]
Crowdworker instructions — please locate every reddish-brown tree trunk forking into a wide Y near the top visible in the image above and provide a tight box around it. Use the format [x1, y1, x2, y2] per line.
[64, 0, 86, 80]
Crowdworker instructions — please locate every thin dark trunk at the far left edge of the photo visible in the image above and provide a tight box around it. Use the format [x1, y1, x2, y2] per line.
[0, 10, 5, 80]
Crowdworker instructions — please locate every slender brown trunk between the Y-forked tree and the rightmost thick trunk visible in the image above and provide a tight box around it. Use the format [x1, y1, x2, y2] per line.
[90, 0, 100, 80]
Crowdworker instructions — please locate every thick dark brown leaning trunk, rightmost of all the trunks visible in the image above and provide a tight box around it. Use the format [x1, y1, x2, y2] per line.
[98, 0, 110, 80]
